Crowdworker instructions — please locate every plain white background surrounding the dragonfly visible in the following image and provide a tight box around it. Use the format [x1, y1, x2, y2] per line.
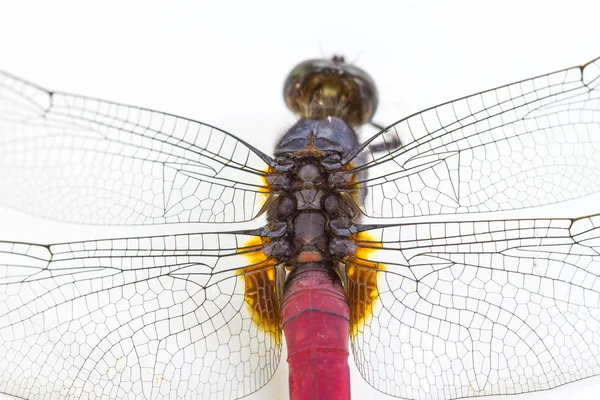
[0, 0, 600, 400]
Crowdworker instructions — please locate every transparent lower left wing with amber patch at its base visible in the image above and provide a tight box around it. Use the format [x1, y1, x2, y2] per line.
[0, 234, 281, 400]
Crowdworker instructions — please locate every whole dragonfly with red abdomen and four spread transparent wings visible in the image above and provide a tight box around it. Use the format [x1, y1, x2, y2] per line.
[0, 57, 600, 400]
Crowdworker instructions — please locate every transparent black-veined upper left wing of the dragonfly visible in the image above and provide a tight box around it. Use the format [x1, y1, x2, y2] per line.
[0, 72, 270, 225]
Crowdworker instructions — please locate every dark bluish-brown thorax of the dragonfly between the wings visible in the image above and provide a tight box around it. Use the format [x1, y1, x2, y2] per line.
[264, 136, 357, 282]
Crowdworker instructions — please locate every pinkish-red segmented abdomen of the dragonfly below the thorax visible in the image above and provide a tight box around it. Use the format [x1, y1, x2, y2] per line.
[282, 265, 350, 400]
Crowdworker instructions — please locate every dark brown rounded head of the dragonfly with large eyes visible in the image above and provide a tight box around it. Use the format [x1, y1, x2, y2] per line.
[283, 56, 378, 126]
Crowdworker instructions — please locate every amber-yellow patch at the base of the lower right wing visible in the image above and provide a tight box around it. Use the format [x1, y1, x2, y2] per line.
[344, 232, 384, 338]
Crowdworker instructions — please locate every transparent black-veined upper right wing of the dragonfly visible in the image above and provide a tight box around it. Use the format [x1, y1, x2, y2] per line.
[351, 55, 600, 218]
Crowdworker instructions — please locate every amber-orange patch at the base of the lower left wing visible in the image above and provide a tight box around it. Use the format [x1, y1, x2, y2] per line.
[236, 236, 281, 344]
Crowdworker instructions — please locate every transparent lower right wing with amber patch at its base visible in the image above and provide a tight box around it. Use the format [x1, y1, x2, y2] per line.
[348, 215, 600, 399]
